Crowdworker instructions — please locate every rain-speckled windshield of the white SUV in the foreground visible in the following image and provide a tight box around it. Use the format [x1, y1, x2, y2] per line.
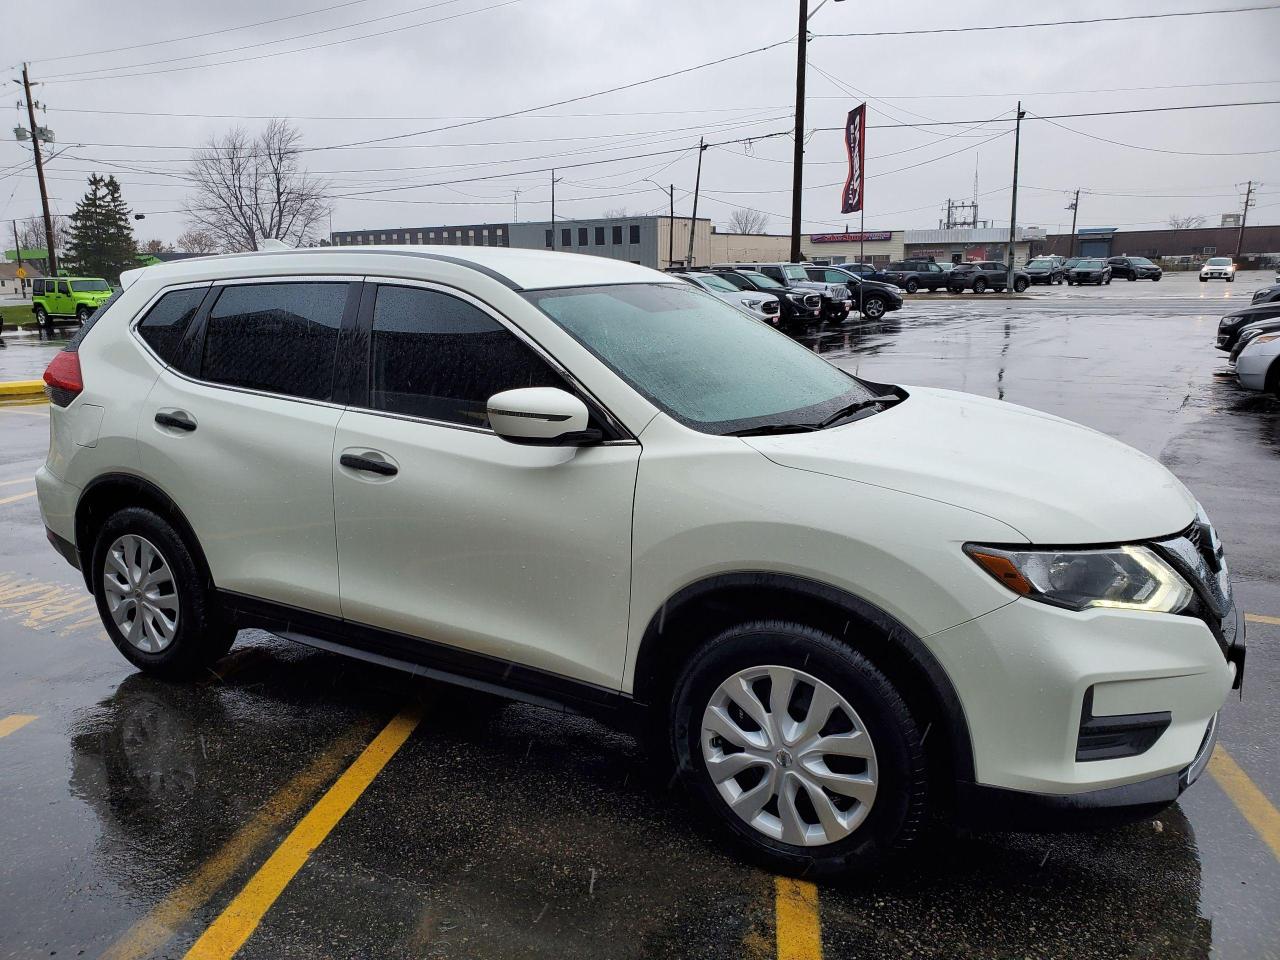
[525, 283, 876, 434]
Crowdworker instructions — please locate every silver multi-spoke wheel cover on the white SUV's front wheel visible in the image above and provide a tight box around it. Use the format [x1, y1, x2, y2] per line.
[700, 666, 879, 846]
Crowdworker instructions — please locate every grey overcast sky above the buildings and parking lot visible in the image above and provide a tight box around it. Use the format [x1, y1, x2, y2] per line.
[0, 0, 1280, 241]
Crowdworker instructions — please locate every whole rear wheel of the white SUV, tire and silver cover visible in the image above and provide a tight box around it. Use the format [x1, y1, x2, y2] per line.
[91, 507, 236, 677]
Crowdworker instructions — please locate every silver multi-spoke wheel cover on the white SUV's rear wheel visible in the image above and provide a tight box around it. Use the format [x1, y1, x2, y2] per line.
[102, 534, 178, 653]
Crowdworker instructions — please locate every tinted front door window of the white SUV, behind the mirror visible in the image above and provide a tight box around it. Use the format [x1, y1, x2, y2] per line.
[370, 287, 564, 426]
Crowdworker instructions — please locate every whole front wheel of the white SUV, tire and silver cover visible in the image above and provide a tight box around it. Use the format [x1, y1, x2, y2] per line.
[671, 621, 927, 877]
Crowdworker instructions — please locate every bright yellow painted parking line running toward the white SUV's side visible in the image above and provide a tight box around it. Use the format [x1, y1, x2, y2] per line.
[187, 707, 422, 960]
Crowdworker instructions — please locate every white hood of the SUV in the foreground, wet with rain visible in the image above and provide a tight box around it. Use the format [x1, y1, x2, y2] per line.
[745, 387, 1196, 545]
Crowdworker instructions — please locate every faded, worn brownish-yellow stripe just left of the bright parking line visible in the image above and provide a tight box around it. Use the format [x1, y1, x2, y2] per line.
[101, 723, 369, 960]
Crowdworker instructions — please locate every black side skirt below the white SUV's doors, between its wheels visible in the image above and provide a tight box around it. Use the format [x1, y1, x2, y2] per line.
[218, 590, 645, 732]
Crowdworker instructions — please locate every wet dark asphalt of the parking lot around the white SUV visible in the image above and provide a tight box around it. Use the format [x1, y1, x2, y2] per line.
[0, 274, 1280, 959]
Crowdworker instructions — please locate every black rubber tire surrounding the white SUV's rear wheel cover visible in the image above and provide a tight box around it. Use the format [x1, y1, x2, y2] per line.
[90, 507, 236, 678]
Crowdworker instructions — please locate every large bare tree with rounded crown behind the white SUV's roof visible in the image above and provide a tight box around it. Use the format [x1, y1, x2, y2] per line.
[184, 119, 330, 252]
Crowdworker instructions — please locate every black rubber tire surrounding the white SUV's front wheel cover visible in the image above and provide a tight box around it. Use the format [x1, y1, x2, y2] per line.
[669, 621, 928, 878]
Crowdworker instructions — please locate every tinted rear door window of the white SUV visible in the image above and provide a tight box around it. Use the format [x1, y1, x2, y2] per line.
[201, 283, 347, 399]
